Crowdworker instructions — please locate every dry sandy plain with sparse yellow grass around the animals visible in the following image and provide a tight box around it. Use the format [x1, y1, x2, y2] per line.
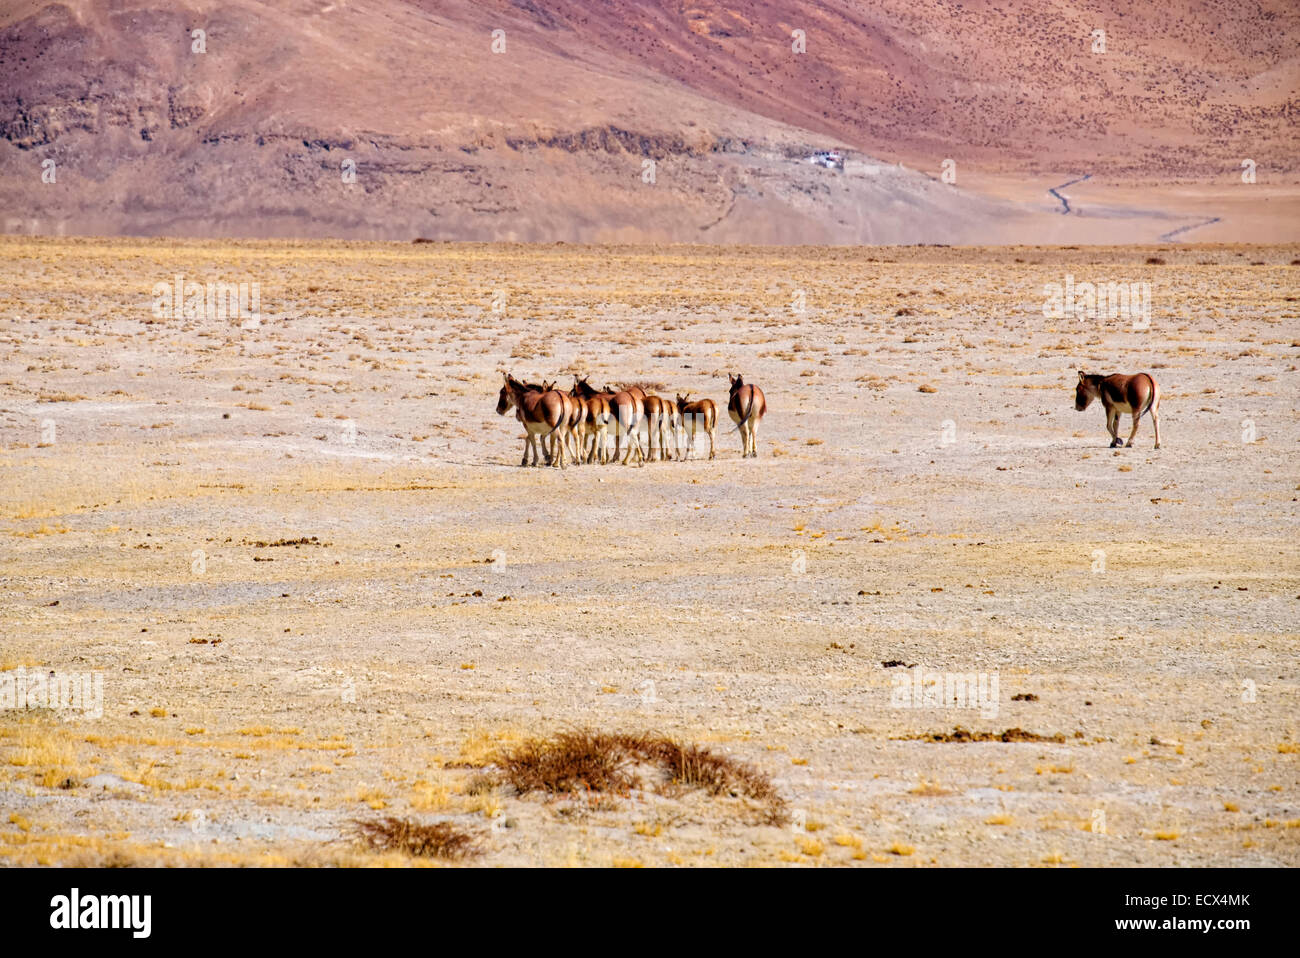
[0, 238, 1300, 867]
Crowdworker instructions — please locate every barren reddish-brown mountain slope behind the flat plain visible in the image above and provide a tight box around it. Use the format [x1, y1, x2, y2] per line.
[0, 0, 1300, 243]
